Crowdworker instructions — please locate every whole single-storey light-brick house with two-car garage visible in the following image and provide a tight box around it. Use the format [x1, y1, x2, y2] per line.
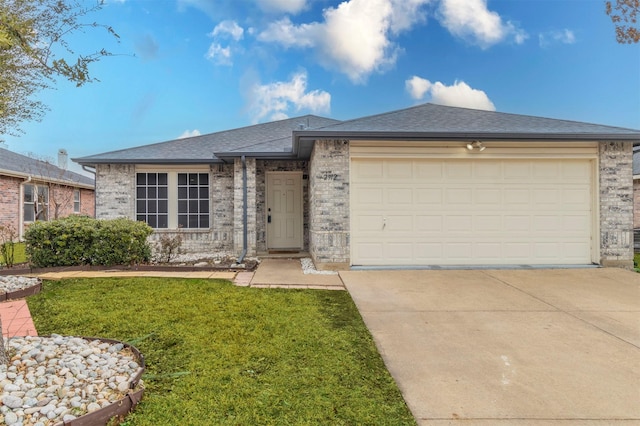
[74, 104, 640, 269]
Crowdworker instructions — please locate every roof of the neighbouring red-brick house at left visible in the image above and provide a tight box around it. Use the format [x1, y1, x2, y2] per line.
[0, 148, 95, 189]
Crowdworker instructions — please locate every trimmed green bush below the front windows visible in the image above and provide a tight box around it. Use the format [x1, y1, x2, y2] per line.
[24, 216, 153, 268]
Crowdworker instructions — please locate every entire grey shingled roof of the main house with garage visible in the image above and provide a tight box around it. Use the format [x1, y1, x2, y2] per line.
[73, 104, 640, 164]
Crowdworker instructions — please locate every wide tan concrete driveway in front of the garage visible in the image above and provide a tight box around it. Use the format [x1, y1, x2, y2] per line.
[340, 269, 640, 426]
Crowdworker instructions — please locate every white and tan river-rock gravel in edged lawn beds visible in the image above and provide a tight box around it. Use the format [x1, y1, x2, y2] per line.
[0, 276, 143, 426]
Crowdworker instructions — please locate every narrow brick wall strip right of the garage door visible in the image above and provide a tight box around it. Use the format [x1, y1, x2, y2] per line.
[599, 142, 633, 268]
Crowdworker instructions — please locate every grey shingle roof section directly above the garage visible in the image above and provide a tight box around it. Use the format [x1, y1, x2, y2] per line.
[301, 104, 640, 140]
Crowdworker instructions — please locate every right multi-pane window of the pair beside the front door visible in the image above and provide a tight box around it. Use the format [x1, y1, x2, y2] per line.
[178, 173, 209, 228]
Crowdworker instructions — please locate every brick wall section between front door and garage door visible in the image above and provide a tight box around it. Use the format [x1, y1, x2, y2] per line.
[309, 140, 350, 269]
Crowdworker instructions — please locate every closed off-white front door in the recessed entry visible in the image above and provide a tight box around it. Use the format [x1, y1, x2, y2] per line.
[266, 172, 302, 249]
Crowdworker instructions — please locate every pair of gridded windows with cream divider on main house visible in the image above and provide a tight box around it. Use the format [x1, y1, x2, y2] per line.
[136, 172, 210, 229]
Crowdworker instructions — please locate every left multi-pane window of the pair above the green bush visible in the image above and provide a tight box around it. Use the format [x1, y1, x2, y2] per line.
[136, 173, 169, 228]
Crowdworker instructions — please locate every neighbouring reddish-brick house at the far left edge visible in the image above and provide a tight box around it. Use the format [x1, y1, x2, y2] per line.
[0, 147, 95, 238]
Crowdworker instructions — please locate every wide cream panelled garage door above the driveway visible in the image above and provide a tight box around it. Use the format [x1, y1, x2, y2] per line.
[351, 158, 593, 265]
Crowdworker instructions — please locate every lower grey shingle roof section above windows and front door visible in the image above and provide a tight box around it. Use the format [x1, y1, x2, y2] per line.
[73, 115, 338, 164]
